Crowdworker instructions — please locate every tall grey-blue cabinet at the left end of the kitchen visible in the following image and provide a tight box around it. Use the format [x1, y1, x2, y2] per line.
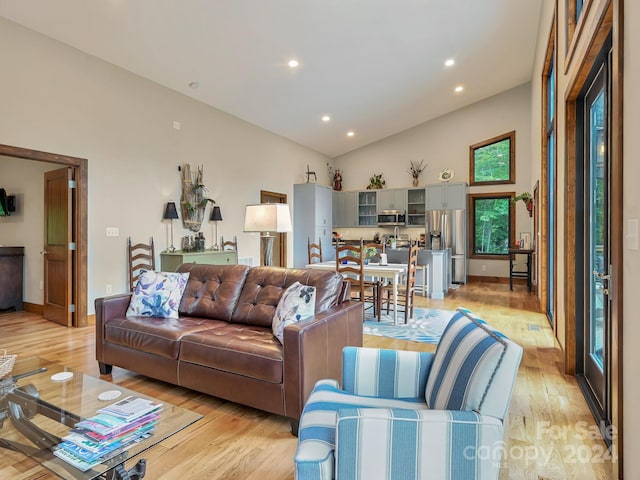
[293, 183, 334, 268]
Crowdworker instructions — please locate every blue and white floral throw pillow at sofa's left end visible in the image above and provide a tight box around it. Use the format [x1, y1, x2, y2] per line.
[127, 270, 189, 318]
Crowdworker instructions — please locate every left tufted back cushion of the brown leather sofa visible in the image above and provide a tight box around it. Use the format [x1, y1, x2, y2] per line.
[177, 263, 251, 322]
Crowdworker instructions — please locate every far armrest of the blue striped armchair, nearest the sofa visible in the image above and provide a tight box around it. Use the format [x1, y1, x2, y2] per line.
[342, 347, 434, 400]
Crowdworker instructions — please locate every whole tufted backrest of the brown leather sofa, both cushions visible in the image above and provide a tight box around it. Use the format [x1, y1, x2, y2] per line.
[177, 263, 343, 328]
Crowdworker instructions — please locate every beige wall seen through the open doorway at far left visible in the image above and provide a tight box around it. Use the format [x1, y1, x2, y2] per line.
[0, 156, 56, 305]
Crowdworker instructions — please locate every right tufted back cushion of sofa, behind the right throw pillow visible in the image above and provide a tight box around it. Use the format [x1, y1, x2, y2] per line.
[231, 267, 342, 329]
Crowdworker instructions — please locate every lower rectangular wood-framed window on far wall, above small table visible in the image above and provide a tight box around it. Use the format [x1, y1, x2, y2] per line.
[469, 192, 515, 259]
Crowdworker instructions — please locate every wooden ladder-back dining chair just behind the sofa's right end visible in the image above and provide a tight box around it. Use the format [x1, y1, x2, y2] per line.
[336, 240, 380, 315]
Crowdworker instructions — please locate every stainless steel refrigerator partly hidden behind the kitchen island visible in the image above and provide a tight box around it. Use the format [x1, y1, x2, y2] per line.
[425, 210, 467, 283]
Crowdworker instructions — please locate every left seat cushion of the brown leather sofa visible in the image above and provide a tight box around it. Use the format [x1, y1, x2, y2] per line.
[104, 316, 211, 360]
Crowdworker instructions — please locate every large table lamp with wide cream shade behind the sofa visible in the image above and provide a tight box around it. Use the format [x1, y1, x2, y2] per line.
[244, 203, 292, 265]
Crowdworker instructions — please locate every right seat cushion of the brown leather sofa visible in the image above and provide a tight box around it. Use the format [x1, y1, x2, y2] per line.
[180, 320, 283, 384]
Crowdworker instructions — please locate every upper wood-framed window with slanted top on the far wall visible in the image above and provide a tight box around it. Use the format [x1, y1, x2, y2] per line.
[469, 131, 516, 185]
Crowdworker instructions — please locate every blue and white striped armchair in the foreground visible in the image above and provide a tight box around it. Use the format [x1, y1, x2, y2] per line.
[294, 309, 522, 480]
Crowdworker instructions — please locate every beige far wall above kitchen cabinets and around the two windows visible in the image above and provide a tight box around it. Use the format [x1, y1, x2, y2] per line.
[334, 83, 533, 277]
